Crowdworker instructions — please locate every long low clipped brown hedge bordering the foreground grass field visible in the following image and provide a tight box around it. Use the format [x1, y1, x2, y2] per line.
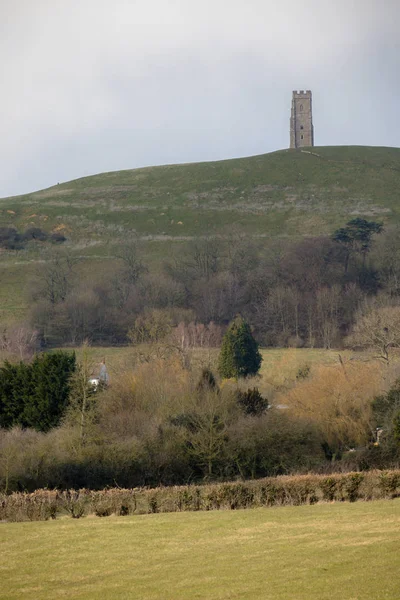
[0, 469, 400, 522]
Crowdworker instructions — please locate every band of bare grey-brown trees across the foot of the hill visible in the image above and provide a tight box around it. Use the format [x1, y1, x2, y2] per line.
[14, 218, 400, 348]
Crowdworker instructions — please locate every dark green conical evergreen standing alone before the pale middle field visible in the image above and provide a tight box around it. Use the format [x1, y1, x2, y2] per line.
[218, 317, 262, 379]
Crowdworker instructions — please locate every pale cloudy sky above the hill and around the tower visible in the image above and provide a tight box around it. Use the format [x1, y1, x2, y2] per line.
[0, 0, 400, 197]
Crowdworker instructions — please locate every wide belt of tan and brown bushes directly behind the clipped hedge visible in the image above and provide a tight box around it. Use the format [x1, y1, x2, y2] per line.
[0, 353, 400, 493]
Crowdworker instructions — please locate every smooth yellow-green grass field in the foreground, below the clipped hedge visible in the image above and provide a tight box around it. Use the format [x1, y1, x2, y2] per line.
[0, 500, 400, 600]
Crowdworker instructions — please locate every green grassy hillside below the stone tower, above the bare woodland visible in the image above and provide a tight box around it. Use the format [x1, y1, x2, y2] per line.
[0, 146, 400, 324]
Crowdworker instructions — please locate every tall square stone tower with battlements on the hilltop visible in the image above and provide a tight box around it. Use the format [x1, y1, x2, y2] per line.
[290, 90, 314, 148]
